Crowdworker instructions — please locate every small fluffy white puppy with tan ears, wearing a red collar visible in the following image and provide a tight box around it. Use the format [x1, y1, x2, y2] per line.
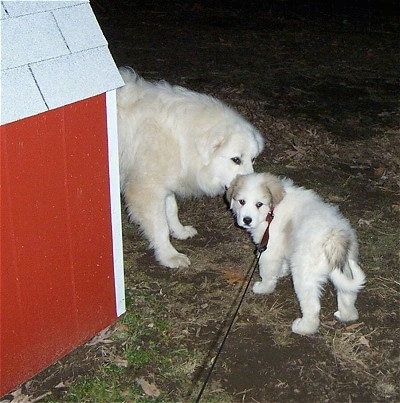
[226, 173, 365, 335]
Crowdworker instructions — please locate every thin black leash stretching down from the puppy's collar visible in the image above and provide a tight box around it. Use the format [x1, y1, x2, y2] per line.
[196, 211, 274, 403]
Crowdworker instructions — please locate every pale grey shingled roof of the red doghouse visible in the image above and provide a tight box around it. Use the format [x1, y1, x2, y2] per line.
[0, 0, 123, 124]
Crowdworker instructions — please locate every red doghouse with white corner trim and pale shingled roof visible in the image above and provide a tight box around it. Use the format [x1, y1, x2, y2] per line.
[0, 1, 125, 396]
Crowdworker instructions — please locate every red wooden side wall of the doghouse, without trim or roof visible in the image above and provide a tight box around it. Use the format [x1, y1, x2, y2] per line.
[0, 94, 117, 396]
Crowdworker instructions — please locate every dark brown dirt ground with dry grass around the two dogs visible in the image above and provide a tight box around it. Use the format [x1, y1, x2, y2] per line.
[3, 0, 400, 402]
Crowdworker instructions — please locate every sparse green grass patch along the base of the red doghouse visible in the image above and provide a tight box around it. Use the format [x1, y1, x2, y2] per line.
[41, 282, 180, 402]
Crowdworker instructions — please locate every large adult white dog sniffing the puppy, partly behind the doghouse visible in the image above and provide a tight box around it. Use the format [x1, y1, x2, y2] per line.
[117, 68, 263, 267]
